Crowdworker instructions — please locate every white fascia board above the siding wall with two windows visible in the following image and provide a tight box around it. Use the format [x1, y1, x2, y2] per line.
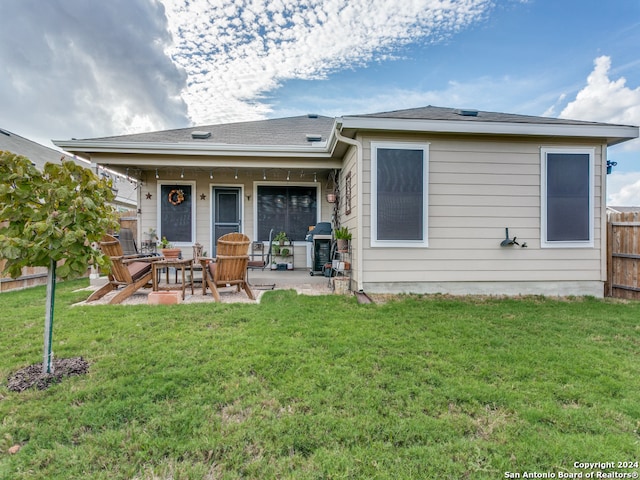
[338, 117, 639, 145]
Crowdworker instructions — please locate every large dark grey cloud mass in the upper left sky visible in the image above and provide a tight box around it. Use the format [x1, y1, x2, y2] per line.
[0, 0, 188, 144]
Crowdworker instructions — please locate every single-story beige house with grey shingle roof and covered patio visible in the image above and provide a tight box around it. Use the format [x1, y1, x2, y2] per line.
[54, 106, 638, 297]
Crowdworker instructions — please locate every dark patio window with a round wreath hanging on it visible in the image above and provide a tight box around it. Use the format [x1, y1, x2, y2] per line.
[158, 183, 195, 244]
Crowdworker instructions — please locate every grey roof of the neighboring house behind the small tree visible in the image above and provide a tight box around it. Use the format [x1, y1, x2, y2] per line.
[0, 128, 138, 208]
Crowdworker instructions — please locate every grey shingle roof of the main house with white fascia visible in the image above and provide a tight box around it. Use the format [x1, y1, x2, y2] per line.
[54, 106, 638, 158]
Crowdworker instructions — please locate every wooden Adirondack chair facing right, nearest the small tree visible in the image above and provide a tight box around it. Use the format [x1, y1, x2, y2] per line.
[87, 235, 162, 305]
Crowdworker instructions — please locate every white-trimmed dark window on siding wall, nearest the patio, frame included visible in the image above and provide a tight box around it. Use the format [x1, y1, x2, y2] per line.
[371, 143, 429, 247]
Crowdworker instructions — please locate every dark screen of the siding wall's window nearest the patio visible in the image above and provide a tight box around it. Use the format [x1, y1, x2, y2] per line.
[375, 148, 426, 241]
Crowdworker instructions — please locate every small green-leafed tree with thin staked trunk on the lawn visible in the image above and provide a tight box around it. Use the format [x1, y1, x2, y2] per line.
[0, 152, 117, 373]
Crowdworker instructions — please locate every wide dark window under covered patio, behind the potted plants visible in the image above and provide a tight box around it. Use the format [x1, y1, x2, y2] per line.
[257, 184, 318, 241]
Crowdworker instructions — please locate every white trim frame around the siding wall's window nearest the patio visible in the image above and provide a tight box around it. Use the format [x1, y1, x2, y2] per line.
[370, 142, 430, 248]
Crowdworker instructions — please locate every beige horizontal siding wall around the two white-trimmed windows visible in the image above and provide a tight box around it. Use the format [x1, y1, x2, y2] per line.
[362, 135, 604, 292]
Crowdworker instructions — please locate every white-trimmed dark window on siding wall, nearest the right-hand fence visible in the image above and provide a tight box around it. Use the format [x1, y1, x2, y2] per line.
[541, 148, 594, 247]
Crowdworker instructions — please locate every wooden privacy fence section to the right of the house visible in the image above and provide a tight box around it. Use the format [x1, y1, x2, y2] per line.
[605, 212, 640, 299]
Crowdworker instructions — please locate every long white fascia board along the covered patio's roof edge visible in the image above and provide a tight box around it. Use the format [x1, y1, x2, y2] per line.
[53, 140, 330, 158]
